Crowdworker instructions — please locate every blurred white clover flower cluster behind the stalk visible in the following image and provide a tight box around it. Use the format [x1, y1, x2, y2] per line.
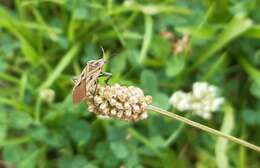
[170, 82, 224, 119]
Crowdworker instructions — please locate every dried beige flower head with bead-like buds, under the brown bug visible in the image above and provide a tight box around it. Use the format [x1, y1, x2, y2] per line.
[87, 84, 152, 121]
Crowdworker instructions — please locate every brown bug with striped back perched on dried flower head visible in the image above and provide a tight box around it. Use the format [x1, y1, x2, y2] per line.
[72, 59, 112, 104]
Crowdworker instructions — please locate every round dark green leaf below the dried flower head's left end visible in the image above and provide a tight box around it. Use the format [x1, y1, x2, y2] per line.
[67, 120, 91, 143]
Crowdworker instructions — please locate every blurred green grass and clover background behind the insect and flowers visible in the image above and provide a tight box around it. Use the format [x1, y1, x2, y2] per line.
[0, 0, 260, 168]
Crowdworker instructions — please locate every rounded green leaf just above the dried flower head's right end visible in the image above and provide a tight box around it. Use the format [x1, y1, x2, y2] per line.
[141, 70, 158, 94]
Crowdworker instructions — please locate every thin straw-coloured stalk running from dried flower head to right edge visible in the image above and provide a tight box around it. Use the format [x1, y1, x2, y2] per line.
[148, 105, 260, 152]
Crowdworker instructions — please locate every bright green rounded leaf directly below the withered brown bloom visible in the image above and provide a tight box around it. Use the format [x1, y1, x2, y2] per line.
[166, 57, 185, 77]
